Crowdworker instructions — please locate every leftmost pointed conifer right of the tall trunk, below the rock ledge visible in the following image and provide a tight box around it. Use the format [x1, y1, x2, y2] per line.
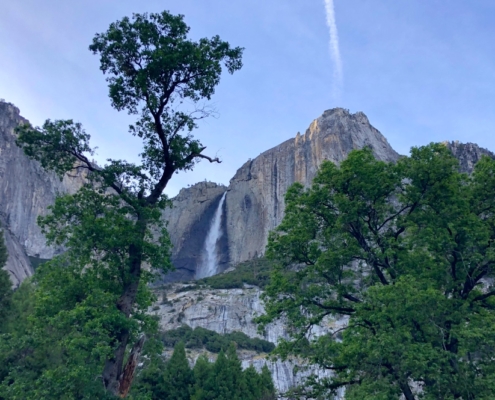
[164, 342, 194, 400]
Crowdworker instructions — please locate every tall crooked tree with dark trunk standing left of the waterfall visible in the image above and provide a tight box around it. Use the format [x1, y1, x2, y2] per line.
[17, 11, 242, 396]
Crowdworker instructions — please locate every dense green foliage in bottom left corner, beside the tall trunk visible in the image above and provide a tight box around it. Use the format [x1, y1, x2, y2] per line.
[0, 258, 124, 399]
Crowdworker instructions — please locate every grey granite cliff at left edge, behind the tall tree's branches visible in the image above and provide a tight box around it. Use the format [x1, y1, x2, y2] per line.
[0, 101, 84, 286]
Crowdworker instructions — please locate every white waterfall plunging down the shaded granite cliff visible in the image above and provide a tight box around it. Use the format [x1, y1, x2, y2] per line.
[196, 192, 227, 279]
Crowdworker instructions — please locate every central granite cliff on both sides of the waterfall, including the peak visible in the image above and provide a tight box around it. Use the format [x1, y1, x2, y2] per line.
[165, 108, 399, 280]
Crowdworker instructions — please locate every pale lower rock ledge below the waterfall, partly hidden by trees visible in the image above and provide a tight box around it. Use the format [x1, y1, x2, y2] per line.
[151, 284, 346, 393]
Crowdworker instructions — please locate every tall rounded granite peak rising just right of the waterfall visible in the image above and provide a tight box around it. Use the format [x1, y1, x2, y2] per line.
[226, 108, 399, 264]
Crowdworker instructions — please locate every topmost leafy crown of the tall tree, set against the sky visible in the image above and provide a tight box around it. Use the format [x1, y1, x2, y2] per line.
[89, 11, 243, 181]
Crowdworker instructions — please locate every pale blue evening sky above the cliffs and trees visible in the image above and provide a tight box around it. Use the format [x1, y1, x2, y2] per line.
[0, 0, 495, 195]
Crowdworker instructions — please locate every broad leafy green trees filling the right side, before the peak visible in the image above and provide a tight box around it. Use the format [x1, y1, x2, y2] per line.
[260, 144, 495, 399]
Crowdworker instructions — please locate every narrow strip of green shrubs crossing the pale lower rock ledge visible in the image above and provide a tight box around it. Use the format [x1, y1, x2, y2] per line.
[160, 325, 275, 353]
